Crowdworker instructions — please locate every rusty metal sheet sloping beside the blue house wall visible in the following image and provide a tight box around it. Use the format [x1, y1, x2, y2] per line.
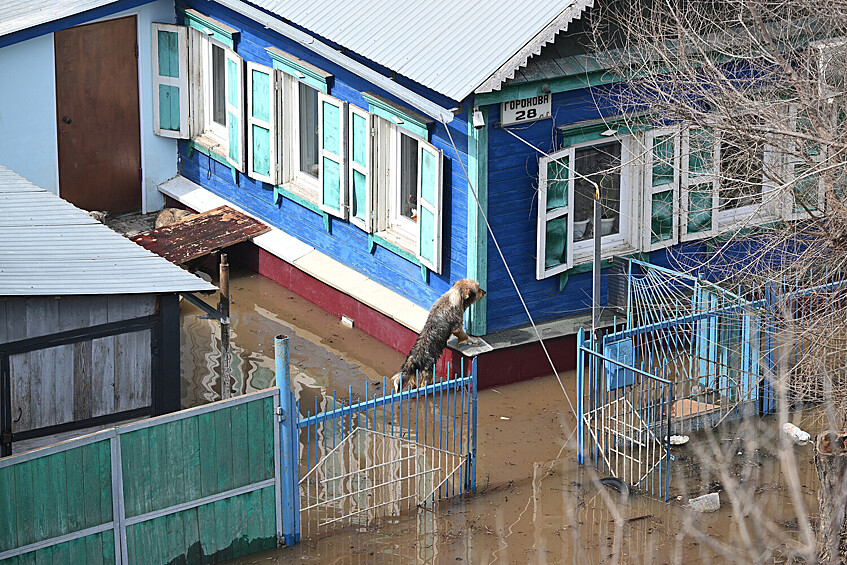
[131, 206, 271, 265]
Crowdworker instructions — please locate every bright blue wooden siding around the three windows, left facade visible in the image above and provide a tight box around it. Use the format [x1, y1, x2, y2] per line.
[179, 0, 467, 308]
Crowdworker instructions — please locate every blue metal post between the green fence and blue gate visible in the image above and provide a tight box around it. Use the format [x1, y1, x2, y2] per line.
[274, 335, 300, 545]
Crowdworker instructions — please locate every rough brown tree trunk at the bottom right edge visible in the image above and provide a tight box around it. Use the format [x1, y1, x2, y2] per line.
[815, 431, 847, 563]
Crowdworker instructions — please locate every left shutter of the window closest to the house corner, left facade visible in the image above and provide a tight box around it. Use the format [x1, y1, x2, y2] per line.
[347, 104, 374, 233]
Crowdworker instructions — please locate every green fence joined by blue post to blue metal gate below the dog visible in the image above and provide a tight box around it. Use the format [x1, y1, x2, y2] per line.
[0, 336, 477, 564]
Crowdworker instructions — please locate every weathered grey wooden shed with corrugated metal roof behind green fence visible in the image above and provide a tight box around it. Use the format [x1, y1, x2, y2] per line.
[0, 166, 215, 456]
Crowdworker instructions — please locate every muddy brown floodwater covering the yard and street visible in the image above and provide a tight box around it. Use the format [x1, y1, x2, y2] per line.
[181, 271, 819, 564]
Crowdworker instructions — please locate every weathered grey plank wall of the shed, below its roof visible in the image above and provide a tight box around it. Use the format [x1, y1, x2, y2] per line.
[0, 295, 156, 432]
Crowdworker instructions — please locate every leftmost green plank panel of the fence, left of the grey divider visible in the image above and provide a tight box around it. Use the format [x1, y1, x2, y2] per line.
[0, 439, 115, 565]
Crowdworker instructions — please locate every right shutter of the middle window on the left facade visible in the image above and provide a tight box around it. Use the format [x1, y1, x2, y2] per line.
[318, 92, 347, 219]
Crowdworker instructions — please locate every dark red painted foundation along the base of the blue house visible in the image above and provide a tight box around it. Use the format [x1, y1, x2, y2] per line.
[165, 197, 576, 389]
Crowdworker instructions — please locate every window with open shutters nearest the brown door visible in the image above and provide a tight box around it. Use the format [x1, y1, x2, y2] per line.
[152, 17, 244, 172]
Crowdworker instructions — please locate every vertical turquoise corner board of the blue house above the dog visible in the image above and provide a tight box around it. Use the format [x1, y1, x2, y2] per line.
[467, 106, 490, 335]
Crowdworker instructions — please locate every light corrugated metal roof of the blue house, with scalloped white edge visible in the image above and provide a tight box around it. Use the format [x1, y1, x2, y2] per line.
[242, 0, 593, 100]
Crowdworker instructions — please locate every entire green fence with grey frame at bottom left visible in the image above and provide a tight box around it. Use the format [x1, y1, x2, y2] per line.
[0, 389, 283, 565]
